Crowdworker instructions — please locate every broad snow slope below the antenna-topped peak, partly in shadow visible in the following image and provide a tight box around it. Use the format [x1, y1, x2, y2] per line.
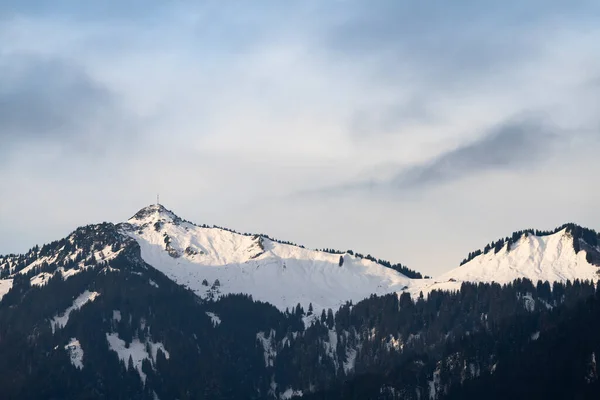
[120, 205, 419, 312]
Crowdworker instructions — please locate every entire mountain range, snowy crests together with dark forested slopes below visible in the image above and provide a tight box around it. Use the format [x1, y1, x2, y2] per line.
[0, 205, 600, 400]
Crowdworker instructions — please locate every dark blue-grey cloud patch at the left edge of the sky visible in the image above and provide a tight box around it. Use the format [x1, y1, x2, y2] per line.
[0, 56, 125, 149]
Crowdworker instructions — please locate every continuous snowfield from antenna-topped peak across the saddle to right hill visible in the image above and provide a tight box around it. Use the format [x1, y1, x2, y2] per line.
[121, 205, 599, 310]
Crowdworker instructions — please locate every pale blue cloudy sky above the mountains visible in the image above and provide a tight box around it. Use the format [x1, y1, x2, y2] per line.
[0, 0, 600, 276]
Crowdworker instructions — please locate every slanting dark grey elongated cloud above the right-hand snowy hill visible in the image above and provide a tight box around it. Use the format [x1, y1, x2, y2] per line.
[390, 120, 557, 189]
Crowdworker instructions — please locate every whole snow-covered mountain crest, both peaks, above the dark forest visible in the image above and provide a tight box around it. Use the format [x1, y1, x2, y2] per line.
[0, 205, 600, 314]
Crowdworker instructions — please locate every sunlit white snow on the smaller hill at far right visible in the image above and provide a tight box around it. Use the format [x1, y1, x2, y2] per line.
[436, 229, 599, 284]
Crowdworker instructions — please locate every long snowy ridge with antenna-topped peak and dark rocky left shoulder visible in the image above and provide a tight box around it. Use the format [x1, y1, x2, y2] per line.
[0, 205, 422, 313]
